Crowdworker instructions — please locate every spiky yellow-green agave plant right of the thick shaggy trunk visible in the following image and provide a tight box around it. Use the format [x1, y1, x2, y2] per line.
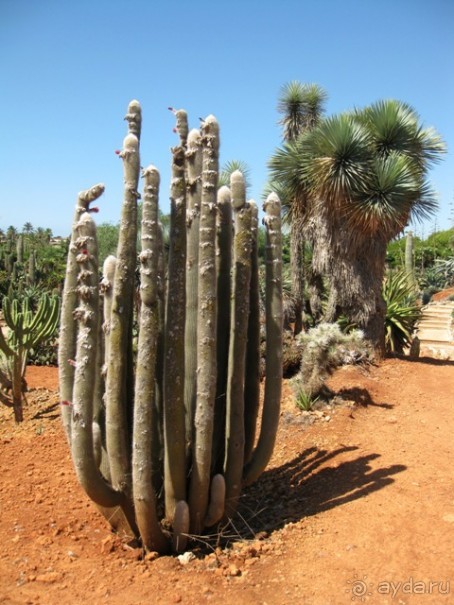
[383, 271, 422, 353]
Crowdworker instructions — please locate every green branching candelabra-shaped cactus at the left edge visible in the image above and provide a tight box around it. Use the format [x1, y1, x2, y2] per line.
[0, 294, 60, 422]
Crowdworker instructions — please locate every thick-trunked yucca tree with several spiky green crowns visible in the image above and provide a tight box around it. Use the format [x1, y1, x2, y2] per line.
[274, 100, 445, 355]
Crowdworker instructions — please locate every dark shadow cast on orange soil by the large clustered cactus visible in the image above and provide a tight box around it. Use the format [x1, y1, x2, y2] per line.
[235, 446, 407, 539]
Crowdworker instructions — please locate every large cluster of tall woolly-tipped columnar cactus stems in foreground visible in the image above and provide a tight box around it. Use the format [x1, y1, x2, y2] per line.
[60, 101, 282, 552]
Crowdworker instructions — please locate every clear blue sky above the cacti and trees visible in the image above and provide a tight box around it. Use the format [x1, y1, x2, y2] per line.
[0, 0, 454, 236]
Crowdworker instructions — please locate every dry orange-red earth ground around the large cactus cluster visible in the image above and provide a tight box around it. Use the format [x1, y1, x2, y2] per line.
[0, 359, 454, 605]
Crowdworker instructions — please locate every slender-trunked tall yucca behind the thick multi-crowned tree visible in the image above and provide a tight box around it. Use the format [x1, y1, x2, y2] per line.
[271, 81, 327, 334]
